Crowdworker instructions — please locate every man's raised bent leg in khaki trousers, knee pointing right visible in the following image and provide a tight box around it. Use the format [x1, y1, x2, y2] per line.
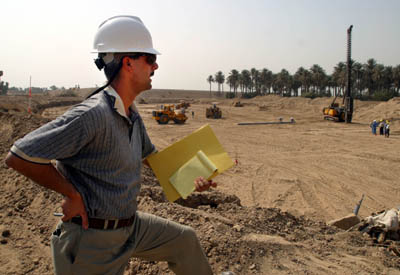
[131, 211, 212, 275]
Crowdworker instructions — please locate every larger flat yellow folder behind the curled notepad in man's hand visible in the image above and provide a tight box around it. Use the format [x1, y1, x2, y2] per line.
[147, 124, 233, 201]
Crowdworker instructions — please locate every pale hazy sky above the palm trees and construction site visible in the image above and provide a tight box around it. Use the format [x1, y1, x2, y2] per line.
[0, 0, 400, 90]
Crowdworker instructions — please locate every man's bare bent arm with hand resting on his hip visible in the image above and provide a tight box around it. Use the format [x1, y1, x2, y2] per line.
[5, 152, 88, 229]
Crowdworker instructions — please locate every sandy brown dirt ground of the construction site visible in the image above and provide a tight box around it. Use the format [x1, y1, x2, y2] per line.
[0, 90, 400, 274]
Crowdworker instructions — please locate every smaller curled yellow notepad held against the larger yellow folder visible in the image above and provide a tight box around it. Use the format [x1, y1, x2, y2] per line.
[169, 150, 218, 199]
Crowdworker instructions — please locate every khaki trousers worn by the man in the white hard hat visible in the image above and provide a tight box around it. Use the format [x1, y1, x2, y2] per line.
[51, 211, 212, 275]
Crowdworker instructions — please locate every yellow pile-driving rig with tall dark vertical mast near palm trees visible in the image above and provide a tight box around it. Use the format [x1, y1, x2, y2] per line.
[322, 25, 354, 123]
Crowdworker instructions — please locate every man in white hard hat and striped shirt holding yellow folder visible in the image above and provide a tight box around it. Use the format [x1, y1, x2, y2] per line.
[6, 16, 216, 275]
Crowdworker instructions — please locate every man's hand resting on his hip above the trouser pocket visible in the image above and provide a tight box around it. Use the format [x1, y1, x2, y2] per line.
[61, 192, 89, 229]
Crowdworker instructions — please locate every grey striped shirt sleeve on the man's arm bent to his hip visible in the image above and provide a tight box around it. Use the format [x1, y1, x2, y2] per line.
[11, 110, 89, 163]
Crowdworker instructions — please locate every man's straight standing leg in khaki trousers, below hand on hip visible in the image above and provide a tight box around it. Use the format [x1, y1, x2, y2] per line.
[51, 222, 132, 275]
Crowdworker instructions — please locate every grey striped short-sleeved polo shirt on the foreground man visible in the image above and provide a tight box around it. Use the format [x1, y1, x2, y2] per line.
[11, 87, 155, 219]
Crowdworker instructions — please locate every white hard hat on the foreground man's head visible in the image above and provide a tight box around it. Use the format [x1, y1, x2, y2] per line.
[93, 15, 160, 55]
